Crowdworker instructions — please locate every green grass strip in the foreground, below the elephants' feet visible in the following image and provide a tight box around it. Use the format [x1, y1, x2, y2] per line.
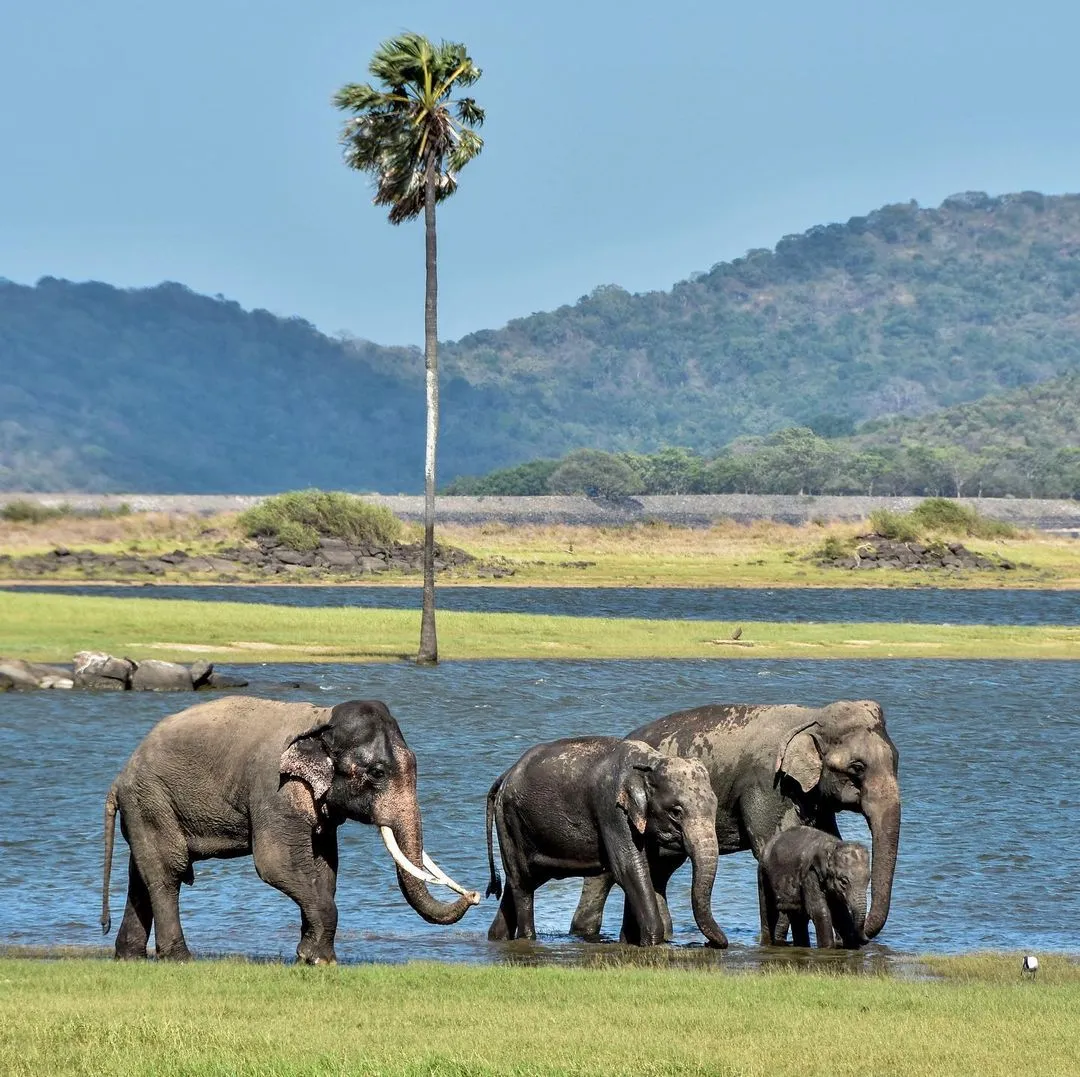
[0, 956, 1080, 1077]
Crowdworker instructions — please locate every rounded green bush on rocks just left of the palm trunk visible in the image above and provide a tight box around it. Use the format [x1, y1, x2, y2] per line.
[240, 489, 402, 550]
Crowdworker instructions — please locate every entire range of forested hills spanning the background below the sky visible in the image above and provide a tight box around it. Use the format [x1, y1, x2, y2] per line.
[6, 192, 1080, 494]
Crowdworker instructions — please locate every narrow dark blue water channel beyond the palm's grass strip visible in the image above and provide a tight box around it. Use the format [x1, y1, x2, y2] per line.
[4, 584, 1080, 624]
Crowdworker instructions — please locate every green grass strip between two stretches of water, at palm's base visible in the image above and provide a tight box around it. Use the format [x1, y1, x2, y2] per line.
[6, 592, 1080, 662]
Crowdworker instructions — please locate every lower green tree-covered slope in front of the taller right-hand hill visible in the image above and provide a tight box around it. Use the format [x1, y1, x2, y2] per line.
[445, 375, 1080, 498]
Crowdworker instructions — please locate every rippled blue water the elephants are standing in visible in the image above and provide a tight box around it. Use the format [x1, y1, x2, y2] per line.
[0, 659, 1080, 962]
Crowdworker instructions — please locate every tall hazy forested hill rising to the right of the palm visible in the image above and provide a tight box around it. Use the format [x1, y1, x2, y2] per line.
[444, 192, 1080, 456]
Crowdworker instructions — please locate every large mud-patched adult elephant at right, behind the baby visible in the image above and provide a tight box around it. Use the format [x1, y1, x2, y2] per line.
[570, 700, 901, 942]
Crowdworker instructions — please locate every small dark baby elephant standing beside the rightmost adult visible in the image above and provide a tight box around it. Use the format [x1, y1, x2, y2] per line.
[757, 826, 870, 950]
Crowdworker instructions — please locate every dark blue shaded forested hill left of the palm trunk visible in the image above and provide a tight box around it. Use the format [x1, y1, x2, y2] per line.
[0, 278, 508, 493]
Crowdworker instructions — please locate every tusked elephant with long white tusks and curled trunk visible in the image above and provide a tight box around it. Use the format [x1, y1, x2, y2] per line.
[102, 696, 481, 965]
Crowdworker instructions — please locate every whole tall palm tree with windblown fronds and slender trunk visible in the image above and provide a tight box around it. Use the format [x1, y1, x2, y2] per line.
[334, 33, 484, 664]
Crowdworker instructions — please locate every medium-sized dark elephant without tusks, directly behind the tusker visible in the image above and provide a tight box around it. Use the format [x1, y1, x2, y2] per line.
[486, 737, 728, 947]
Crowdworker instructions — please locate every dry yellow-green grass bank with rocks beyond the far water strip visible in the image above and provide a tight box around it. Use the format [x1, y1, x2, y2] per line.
[6, 513, 1080, 588]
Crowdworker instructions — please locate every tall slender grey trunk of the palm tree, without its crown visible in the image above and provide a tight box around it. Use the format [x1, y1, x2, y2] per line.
[416, 157, 438, 665]
